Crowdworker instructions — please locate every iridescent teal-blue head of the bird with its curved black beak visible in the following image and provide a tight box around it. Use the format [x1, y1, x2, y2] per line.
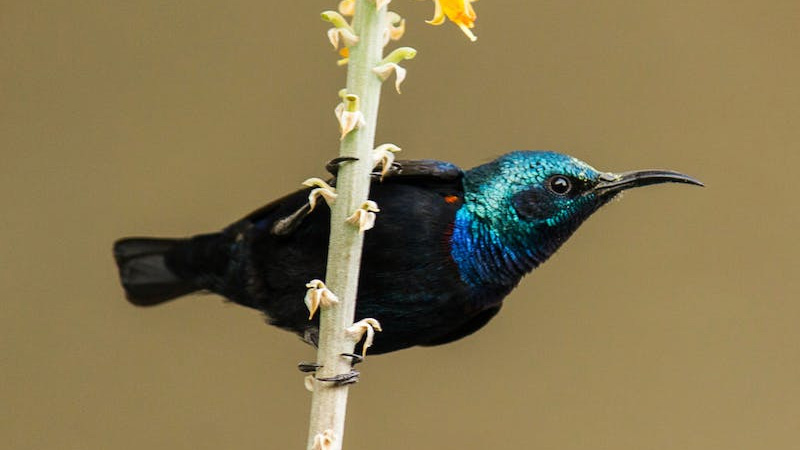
[454, 151, 702, 284]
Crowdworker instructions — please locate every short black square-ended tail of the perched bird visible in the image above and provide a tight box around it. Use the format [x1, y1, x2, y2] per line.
[114, 233, 230, 306]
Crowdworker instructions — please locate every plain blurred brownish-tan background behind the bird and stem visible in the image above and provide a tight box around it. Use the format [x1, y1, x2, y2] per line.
[0, 0, 800, 450]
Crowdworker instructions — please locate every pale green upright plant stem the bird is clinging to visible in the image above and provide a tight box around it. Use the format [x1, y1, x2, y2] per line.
[307, 0, 387, 450]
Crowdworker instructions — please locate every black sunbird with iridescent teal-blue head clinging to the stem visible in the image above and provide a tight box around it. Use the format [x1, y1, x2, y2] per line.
[113, 151, 703, 354]
